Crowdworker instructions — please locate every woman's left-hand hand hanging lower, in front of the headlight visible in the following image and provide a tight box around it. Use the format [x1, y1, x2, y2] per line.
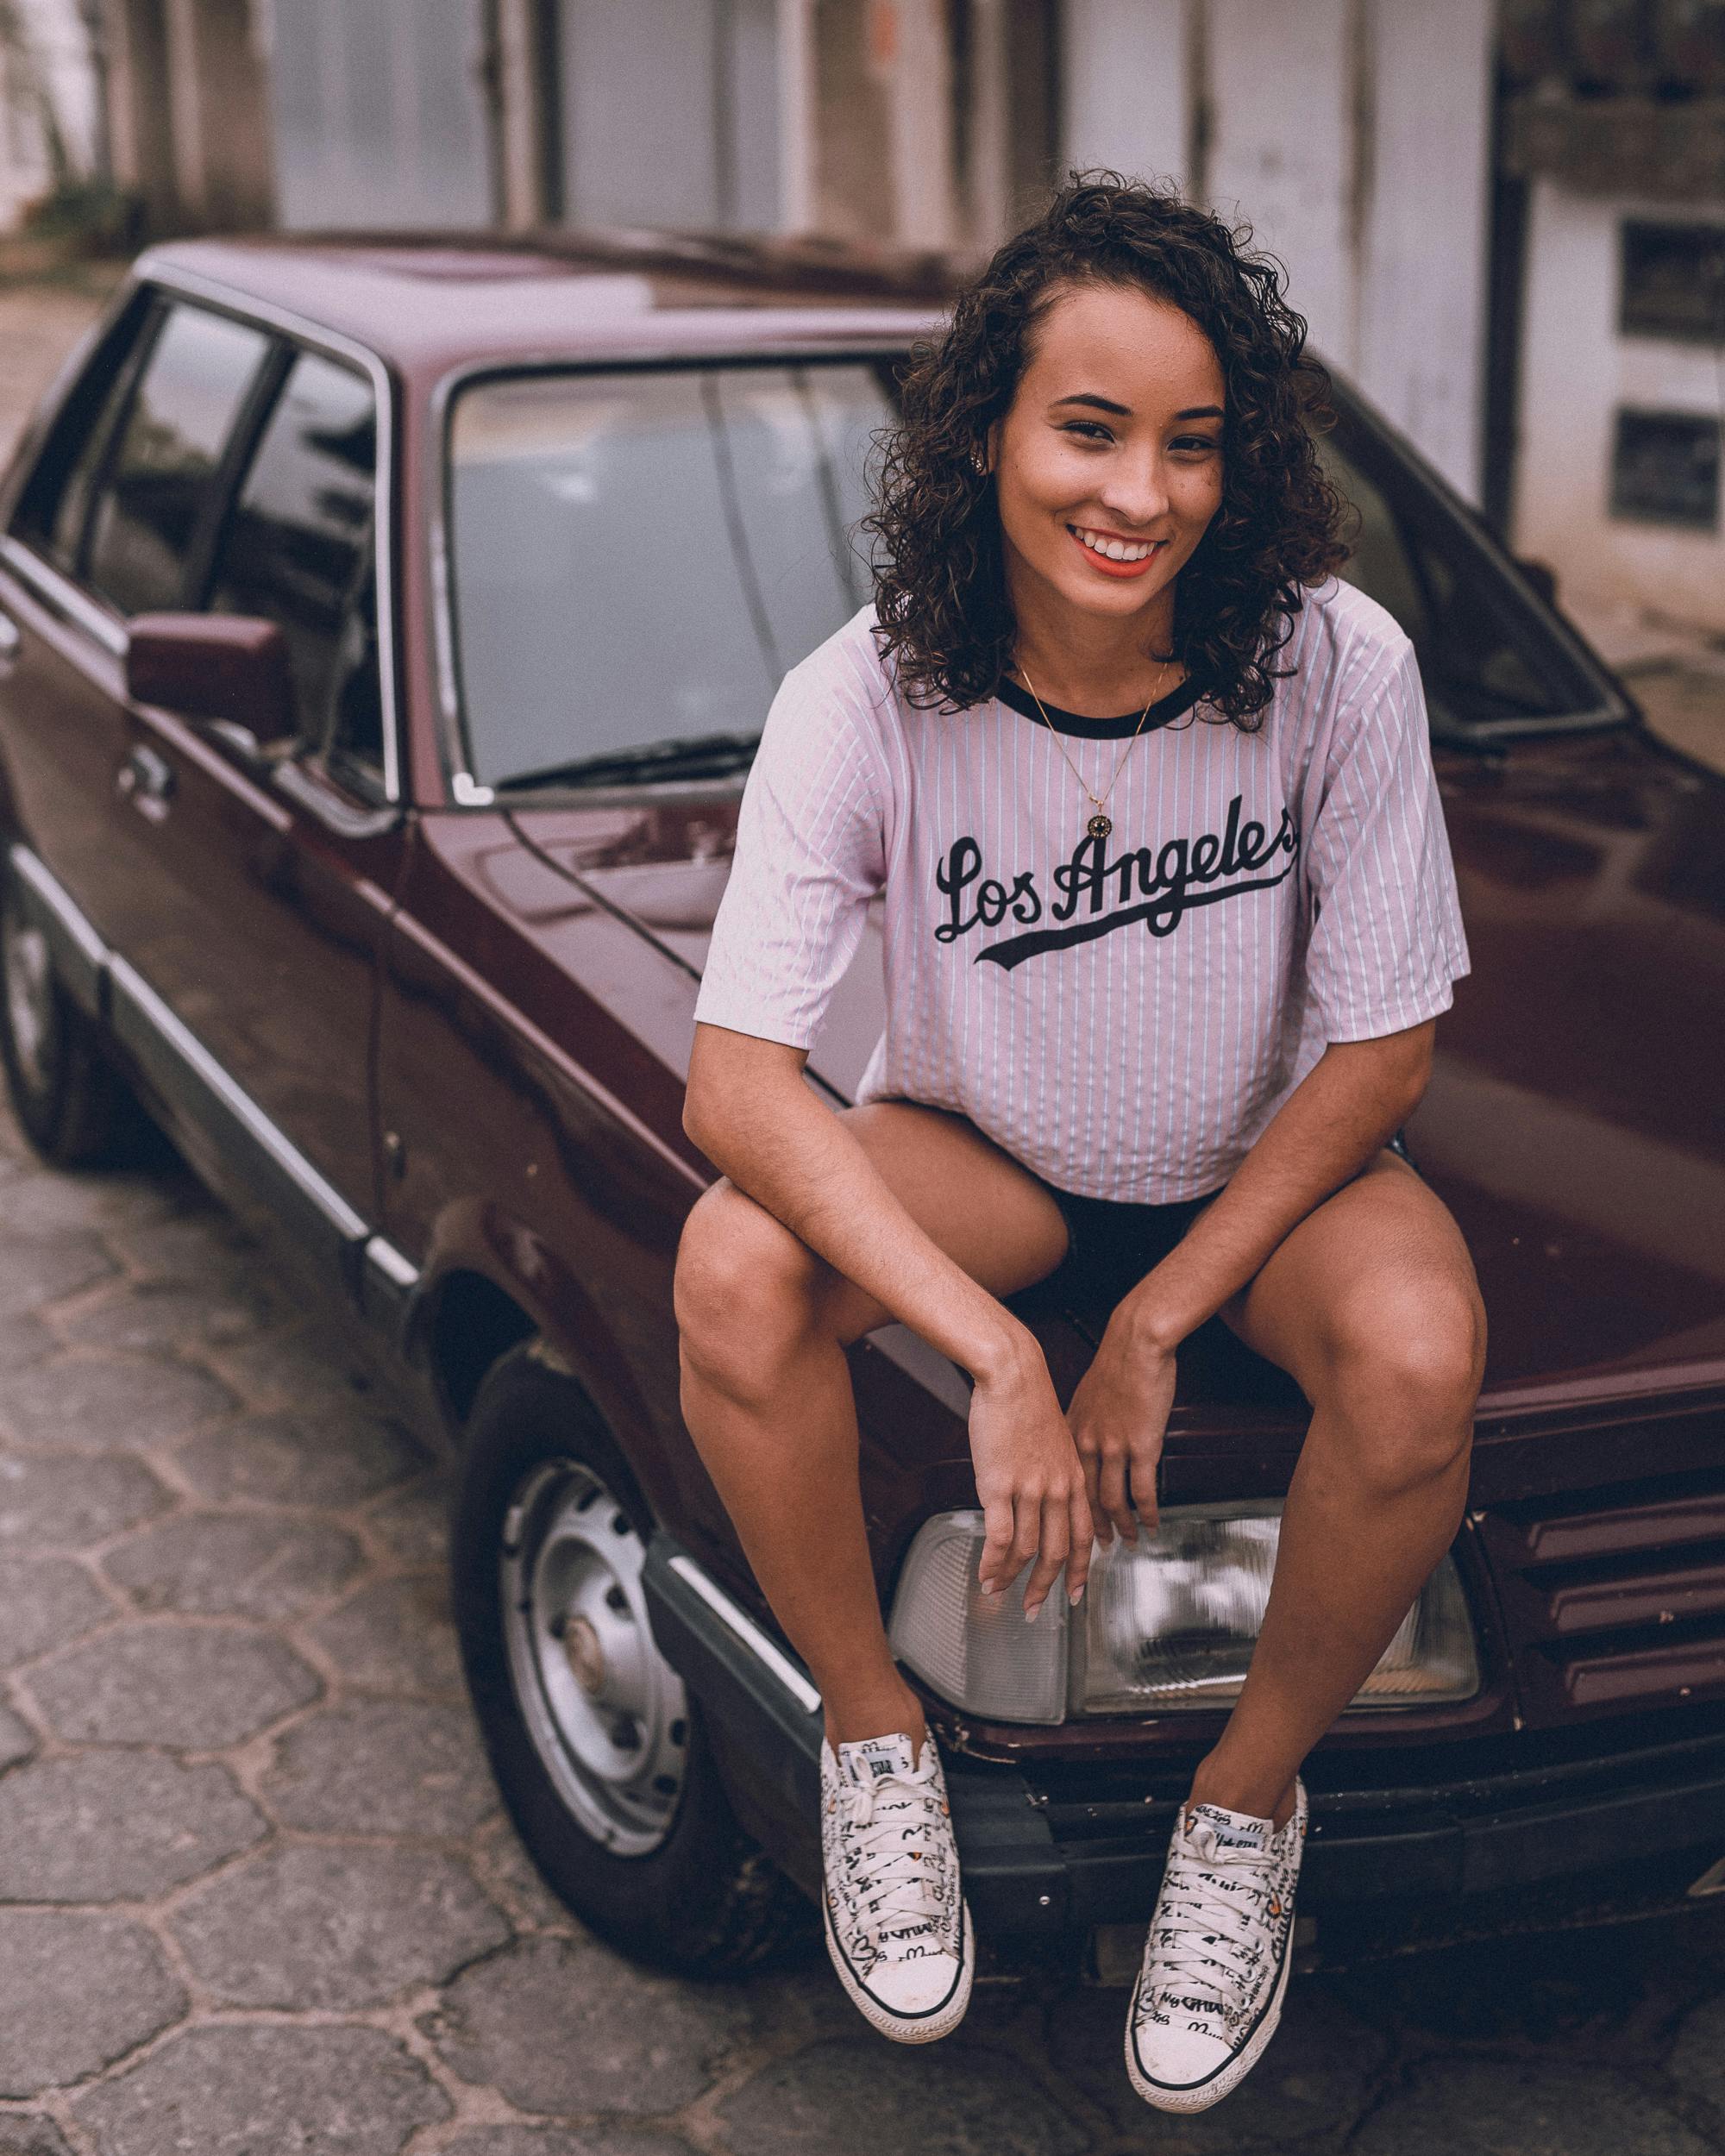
[970, 1341, 1094, 1620]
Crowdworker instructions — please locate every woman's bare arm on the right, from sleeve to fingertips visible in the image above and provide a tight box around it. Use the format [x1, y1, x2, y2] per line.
[1070, 1020, 1436, 1542]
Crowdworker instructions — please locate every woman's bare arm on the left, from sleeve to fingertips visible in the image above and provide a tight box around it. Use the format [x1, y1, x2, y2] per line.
[684, 1025, 1091, 1617]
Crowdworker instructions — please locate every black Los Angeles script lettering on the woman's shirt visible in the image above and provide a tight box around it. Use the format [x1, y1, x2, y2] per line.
[934, 793, 1301, 973]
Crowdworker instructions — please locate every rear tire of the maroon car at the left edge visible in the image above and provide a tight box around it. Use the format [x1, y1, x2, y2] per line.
[0, 875, 147, 1169]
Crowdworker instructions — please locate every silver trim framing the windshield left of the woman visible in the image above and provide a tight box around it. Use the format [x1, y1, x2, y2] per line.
[425, 332, 906, 809]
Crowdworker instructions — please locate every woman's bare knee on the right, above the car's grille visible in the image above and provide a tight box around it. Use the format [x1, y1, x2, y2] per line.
[1322, 1276, 1486, 1490]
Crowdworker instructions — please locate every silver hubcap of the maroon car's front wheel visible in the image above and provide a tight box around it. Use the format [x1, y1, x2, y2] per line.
[499, 1460, 688, 1857]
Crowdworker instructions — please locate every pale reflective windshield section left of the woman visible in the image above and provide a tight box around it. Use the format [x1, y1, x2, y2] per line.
[451, 362, 891, 789]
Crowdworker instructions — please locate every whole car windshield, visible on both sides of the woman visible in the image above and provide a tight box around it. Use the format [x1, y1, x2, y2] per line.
[448, 360, 1620, 792]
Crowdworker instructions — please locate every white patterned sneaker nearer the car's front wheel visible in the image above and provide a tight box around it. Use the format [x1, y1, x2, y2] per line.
[822, 1736, 977, 2044]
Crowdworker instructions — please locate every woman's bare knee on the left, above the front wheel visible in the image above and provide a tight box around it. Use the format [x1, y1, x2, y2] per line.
[675, 1184, 819, 1400]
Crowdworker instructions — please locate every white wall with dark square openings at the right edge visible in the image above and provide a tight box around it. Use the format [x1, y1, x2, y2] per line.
[1516, 181, 1725, 632]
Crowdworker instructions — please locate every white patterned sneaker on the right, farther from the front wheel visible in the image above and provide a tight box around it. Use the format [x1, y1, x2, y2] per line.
[1126, 1781, 1307, 2111]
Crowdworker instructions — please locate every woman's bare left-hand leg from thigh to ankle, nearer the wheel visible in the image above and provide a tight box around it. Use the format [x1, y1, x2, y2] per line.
[677, 1102, 1065, 1746]
